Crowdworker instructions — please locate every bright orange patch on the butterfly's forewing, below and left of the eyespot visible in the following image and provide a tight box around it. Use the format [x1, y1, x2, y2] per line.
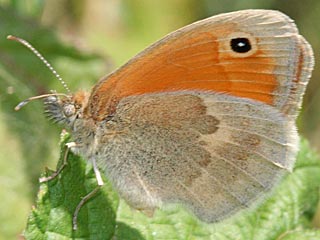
[89, 25, 277, 119]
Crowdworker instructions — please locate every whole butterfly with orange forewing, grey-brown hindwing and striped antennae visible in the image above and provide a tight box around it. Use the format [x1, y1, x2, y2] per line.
[9, 10, 314, 230]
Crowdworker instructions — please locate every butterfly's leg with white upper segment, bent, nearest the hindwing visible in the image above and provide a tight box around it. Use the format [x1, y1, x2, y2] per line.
[72, 158, 104, 230]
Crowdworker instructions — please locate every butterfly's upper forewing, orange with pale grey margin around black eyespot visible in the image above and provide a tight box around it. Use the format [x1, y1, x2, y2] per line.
[88, 10, 312, 119]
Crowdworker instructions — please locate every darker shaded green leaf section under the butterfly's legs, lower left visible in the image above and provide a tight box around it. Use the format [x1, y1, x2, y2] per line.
[24, 133, 118, 240]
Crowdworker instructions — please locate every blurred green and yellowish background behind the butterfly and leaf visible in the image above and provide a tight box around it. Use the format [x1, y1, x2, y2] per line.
[0, 0, 320, 239]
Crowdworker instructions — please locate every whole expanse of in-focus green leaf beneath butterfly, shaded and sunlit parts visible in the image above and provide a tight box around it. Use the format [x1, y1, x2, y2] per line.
[25, 136, 320, 240]
